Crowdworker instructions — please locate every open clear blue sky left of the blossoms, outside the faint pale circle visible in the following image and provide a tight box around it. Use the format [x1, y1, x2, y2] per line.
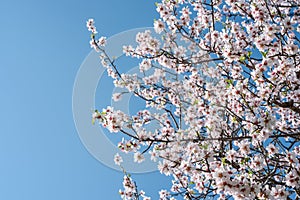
[0, 0, 171, 200]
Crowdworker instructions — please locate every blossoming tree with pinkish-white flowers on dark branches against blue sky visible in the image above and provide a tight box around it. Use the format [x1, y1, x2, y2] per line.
[87, 0, 300, 200]
